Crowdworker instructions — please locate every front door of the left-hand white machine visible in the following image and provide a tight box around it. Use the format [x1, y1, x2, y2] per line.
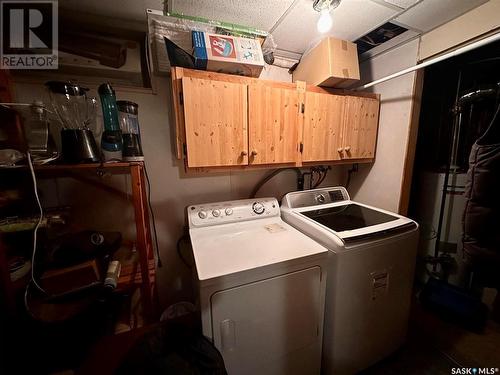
[211, 267, 324, 375]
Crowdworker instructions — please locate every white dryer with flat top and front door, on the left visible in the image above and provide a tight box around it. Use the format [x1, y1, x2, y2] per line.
[187, 198, 328, 375]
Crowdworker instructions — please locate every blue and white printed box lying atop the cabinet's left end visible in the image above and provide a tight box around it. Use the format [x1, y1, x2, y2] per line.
[192, 31, 264, 77]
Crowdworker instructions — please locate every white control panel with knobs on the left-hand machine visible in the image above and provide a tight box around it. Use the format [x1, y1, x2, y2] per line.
[187, 198, 280, 228]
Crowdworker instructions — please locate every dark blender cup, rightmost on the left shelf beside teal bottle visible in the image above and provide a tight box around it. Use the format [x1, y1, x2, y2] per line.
[116, 100, 144, 161]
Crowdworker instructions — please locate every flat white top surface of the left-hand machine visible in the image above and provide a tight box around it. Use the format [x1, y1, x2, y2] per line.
[190, 217, 328, 281]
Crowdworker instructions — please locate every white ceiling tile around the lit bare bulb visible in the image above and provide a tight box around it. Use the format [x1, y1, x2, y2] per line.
[273, 0, 397, 53]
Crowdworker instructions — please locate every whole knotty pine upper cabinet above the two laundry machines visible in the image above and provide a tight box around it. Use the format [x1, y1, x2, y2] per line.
[172, 67, 380, 168]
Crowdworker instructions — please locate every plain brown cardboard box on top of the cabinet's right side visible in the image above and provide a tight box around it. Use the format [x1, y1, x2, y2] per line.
[293, 37, 359, 88]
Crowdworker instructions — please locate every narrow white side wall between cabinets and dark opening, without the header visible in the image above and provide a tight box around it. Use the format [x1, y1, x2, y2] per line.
[348, 40, 418, 212]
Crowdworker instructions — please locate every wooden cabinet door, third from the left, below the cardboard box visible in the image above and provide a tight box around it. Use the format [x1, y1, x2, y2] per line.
[302, 92, 345, 162]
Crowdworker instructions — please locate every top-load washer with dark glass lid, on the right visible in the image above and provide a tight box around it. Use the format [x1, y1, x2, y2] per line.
[281, 187, 418, 374]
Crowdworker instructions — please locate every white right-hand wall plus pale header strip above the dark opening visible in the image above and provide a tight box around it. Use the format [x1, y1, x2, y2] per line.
[349, 0, 500, 212]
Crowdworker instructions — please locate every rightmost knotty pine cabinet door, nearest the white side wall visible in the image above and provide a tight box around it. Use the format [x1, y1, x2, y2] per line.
[342, 96, 379, 159]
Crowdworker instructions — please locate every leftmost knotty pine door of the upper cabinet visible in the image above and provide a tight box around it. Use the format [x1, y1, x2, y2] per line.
[182, 77, 248, 167]
